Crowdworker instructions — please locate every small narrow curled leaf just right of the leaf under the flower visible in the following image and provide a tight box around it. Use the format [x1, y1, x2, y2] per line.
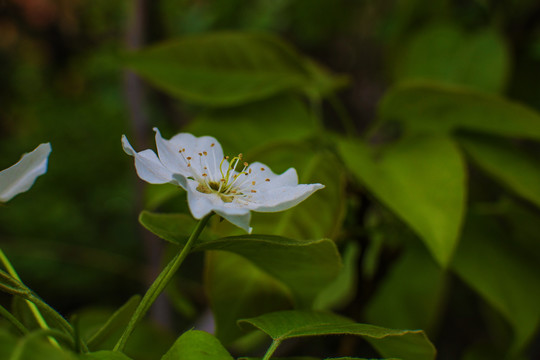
[313, 242, 360, 310]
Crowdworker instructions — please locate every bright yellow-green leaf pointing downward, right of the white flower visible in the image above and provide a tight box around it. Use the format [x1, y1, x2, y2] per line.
[339, 136, 466, 266]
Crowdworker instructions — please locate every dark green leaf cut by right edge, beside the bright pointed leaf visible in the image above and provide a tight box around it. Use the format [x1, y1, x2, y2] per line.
[459, 136, 540, 206]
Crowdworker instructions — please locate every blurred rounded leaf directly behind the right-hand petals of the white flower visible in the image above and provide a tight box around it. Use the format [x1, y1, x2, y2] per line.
[251, 143, 346, 239]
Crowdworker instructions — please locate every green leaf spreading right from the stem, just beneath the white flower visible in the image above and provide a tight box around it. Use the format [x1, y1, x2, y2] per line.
[194, 235, 341, 307]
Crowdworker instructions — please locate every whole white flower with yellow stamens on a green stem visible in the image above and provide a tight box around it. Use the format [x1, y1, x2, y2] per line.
[122, 128, 324, 233]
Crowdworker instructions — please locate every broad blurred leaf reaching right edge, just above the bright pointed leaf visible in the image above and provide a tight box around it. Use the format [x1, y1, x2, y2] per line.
[379, 82, 540, 140]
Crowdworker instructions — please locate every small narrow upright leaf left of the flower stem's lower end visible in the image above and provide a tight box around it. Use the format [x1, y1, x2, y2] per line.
[87, 295, 141, 350]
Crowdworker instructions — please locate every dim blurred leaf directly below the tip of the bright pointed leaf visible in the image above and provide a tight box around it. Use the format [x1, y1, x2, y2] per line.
[365, 244, 445, 330]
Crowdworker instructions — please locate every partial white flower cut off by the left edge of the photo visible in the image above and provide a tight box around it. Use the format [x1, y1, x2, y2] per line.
[0, 143, 51, 202]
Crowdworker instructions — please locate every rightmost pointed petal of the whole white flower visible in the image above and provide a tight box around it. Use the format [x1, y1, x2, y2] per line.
[250, 184, 324, 212]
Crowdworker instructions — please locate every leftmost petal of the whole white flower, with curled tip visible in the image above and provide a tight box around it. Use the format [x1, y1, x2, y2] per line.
[122, 135, 178, 187]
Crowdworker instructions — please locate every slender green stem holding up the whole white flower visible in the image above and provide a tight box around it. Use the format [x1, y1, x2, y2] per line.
[114, 213, 213, 351]
